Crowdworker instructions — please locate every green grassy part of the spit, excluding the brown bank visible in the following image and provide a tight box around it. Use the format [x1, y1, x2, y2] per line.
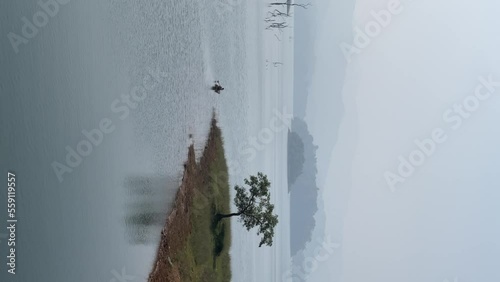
[174, 127, 231, 281]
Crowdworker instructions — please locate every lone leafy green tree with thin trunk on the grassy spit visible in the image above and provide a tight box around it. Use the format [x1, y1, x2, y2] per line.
[216, 172, 278, 247]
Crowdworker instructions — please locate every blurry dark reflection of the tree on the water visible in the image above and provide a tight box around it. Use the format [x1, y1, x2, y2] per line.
[124, 175, 181, 245]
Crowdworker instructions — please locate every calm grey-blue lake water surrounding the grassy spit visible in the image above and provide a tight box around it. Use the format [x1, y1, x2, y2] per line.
[0, 0, 293, 281]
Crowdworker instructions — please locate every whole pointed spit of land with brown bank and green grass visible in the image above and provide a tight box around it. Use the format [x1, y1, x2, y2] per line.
[148, 118, 231, 282]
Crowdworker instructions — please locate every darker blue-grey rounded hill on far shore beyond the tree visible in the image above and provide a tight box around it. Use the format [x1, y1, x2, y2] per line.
[288, 118, 319, 256]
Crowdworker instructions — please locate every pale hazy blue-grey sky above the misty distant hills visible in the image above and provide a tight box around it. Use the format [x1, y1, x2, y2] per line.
[306, 0, 500, 282]
